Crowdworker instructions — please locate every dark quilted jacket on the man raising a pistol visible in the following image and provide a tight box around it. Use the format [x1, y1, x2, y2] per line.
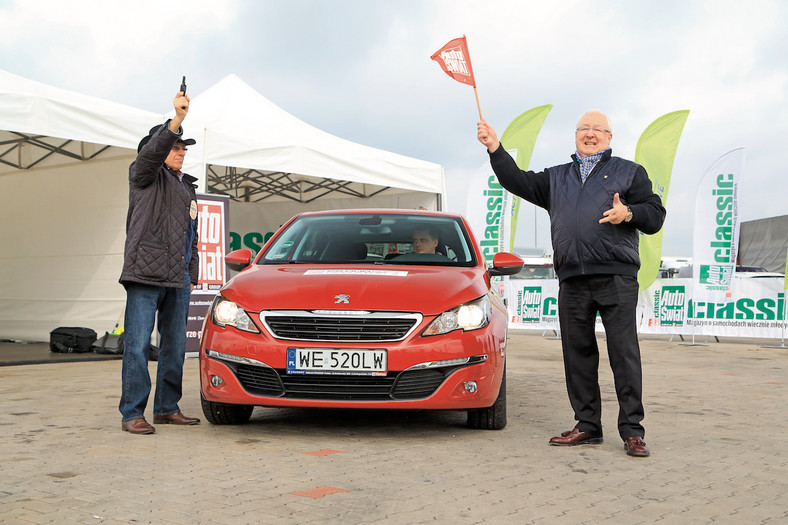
[120, 121, 199, 288]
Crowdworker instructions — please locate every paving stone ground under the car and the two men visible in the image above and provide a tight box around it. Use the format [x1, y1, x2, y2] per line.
[0, 331, 788, 525]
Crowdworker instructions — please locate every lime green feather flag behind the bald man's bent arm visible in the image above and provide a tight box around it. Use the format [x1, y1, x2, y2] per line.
[635, 110, 689, 291]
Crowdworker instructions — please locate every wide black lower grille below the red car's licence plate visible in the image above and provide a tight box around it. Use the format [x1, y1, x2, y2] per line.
[232, 364, 457, 401]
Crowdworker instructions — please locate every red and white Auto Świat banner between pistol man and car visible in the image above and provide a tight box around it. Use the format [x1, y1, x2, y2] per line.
[186, 194, 230, 354]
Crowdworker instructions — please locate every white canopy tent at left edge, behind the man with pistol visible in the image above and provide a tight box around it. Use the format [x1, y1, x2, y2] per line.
[0, 71, 163, 341]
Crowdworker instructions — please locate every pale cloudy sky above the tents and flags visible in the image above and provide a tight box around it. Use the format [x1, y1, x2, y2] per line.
[0, 0, 788, 256]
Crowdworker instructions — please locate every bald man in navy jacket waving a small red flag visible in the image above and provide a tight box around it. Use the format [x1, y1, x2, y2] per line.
[477, 111, 665, 457]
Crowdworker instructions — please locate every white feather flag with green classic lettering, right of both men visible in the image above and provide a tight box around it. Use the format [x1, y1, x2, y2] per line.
[692, 148, 744, 303]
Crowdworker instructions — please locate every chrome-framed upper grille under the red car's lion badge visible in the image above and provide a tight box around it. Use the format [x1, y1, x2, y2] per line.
[260, 311, 422, 342]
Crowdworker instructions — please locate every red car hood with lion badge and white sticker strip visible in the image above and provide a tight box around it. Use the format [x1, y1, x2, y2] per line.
[215, 265, 487, 315]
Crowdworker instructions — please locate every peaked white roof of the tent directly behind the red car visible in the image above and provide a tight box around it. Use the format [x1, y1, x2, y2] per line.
[184, 75, 444, 201]
